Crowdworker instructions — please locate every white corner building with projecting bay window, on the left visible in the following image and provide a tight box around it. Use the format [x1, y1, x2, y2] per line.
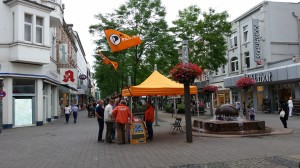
[0, 0, 86, 128]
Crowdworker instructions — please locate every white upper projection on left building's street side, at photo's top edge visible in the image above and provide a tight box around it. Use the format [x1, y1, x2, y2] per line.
[42, 0, 63, 27]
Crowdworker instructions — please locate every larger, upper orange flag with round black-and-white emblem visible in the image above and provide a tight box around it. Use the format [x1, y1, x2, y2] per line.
[104, 29, 142, 52]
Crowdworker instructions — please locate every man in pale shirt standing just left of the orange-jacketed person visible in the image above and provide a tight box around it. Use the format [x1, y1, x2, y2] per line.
[104, 99, 115, 143]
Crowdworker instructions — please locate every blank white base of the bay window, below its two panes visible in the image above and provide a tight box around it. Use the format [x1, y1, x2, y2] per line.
[9, 43, 51, 65]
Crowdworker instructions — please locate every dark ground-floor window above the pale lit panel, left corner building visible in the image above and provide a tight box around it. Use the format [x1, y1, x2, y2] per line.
[13, 79, 35, 94]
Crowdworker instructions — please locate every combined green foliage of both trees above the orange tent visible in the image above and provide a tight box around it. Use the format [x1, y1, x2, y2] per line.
[89, 0, 231, 98]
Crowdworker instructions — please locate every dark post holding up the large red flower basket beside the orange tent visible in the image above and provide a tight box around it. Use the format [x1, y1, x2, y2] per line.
[182, 40, 193, 143]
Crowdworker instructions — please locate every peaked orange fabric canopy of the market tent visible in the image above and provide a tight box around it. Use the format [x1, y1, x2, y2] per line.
[122, 71, 197, 96]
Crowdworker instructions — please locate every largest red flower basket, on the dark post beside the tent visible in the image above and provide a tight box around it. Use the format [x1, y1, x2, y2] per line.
[170, 63, 202, 83]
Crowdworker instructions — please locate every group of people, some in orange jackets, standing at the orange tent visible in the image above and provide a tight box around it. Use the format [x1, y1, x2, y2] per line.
[95, 98, 154, 144]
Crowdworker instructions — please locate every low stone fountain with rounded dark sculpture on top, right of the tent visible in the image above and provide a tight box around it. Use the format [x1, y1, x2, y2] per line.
[193, 104, 266, 135]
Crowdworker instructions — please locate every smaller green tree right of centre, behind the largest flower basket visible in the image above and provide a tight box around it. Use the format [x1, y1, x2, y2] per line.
[170, 6, 231, 71]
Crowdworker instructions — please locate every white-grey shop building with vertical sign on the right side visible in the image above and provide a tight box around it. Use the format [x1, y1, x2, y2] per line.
[206, 1, 300, 112]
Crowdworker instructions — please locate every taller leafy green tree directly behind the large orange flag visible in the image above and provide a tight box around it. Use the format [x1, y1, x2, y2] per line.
[90, 0, 178, 98]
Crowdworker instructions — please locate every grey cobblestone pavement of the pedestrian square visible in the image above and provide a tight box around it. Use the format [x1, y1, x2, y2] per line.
[0, 111, 300, 168]
